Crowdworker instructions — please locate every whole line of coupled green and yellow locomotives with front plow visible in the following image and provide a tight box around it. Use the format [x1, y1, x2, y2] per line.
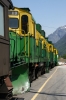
[9, 7, 58, 94]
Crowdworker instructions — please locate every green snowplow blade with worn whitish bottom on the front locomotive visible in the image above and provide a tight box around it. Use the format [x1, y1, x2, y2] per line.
[11, 64, 30, 94]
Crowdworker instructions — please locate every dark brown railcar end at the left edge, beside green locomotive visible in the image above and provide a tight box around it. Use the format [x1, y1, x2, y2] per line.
[0, 0, 13, 100]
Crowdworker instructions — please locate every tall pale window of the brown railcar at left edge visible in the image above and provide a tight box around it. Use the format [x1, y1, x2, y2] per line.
[0, 4, 4, 36]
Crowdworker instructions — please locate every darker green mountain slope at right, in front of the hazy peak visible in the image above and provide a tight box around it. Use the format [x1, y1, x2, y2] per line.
[54, 34, 66, 56]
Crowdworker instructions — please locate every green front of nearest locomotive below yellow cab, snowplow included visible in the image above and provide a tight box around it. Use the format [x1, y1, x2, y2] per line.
[9, 32, 30, 94]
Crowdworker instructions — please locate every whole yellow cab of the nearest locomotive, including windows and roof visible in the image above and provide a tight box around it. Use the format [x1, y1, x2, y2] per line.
[8, 7, 35, 36]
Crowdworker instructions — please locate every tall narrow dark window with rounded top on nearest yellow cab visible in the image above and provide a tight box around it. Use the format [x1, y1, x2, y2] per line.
[21, 15, 28, 34]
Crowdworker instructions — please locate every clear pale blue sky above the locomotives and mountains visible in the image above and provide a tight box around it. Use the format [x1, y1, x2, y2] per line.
[12, 0, 66, 36]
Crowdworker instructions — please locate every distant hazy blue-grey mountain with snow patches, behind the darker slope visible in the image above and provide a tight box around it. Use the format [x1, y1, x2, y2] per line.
[48, 25, 66, 43]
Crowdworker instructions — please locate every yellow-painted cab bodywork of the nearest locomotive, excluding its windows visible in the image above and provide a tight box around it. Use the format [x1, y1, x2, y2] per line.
[9, 7, 35, 36]
